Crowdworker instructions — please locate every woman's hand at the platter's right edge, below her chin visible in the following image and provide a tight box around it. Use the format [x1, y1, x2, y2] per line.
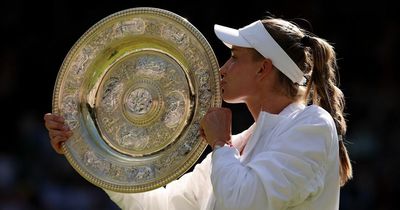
[200, 107, 232, 149]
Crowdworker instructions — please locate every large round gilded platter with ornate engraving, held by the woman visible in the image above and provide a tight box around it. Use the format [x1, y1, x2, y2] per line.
[53, 8, 221, 192]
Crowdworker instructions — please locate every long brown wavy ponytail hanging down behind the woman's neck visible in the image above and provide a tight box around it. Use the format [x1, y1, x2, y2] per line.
[305, 37, 353, 186]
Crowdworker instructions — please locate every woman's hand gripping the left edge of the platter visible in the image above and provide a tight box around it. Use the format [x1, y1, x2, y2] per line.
[44, 113, 72, 154]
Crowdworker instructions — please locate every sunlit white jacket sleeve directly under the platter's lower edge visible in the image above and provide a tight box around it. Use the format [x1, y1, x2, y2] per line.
[104, 154, 212, 210]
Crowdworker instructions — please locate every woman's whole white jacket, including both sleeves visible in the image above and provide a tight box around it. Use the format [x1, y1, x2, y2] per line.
[106, 103, 340, 210]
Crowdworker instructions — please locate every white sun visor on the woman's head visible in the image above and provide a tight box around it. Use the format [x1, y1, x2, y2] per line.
[214, 20, 305, 84]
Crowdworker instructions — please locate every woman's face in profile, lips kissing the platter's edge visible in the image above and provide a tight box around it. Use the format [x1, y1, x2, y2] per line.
[220, 46, 262, 103]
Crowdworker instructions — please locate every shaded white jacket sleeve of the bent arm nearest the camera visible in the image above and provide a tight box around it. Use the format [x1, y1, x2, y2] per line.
[211, 117, 337, 210]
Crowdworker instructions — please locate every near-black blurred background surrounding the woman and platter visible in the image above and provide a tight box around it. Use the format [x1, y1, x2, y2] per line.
[0, 0, 400, 210]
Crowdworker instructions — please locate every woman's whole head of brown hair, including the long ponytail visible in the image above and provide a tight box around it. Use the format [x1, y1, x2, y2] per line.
[262, 18, 353, 186]
